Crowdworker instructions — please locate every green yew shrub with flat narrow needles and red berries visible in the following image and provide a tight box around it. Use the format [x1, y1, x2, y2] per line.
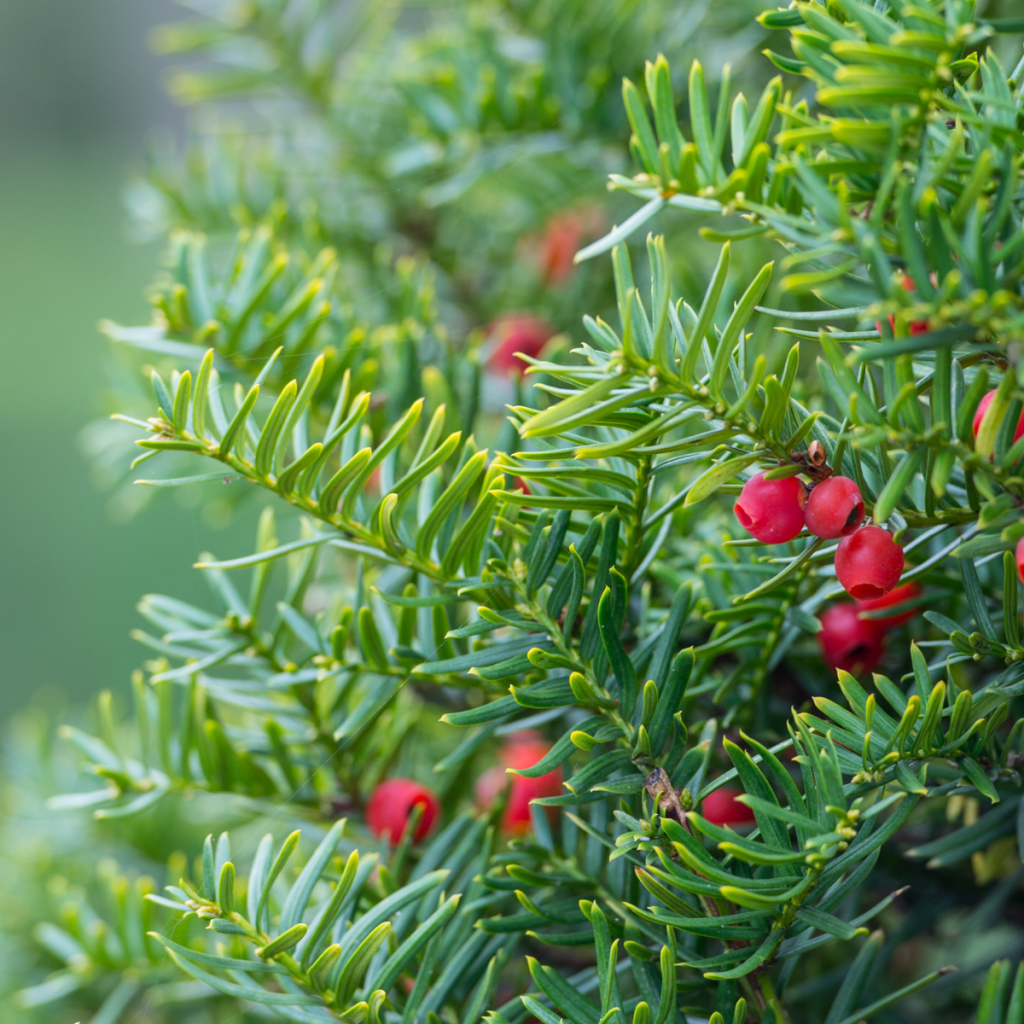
[6, 0, 1024, 1024]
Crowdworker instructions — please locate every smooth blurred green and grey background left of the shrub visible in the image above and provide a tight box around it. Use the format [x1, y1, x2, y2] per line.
[0, 0, 243, 720]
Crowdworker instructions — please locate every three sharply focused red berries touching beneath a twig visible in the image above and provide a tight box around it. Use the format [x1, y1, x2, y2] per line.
[733, 473, 903, 600]
